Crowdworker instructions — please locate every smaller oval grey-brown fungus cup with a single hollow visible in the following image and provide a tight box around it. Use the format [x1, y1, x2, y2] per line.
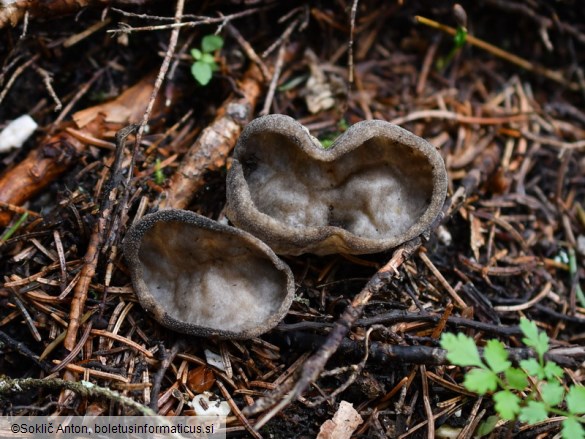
[124, 209, 294, 339]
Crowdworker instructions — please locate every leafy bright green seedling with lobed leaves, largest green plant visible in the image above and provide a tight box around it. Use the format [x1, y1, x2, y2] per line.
[441, 318, 585, 439]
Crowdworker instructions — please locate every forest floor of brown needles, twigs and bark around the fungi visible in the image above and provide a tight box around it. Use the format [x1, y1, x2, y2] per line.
[0, 0, 585, 438]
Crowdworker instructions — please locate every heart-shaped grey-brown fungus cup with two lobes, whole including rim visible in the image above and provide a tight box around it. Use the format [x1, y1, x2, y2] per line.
[227, 115, 447, 255]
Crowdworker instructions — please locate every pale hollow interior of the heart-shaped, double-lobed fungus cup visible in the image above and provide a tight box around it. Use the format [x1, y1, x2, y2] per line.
[243, 133, 433, 239]
